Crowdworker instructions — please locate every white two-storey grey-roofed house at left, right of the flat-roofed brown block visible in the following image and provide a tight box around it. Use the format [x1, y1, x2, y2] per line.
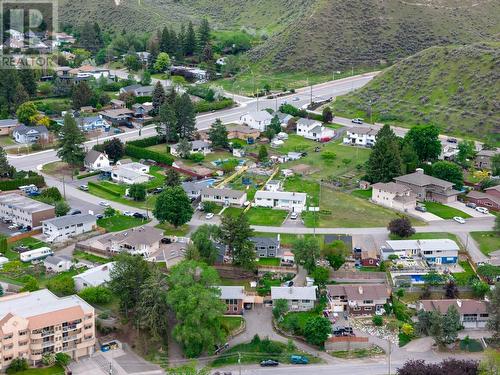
[42, 214, 96, 242]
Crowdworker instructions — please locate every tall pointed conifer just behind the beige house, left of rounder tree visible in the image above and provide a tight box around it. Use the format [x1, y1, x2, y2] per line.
[366, 125, 401, 183]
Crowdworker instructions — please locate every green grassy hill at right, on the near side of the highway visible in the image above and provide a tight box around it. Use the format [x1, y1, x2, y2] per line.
[334, 42, 500, 144]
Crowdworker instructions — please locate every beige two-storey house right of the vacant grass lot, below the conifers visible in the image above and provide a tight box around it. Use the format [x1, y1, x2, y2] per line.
[372, 182, 417, 212]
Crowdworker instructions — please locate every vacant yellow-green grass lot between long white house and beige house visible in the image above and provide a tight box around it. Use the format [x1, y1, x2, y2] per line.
[302, 187, 424, 228]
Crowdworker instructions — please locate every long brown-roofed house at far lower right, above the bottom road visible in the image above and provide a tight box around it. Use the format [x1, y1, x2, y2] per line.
[418, 299, 490, 329]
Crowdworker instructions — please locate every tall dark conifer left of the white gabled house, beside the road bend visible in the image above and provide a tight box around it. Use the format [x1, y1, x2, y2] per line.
[57, 113, 86, 167]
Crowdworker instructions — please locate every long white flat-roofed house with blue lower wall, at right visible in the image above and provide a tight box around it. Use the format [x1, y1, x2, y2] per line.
[381, 238, 460, 264]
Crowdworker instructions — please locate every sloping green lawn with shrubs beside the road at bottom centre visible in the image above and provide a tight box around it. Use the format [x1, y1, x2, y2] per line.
[211, 339, 321, 367]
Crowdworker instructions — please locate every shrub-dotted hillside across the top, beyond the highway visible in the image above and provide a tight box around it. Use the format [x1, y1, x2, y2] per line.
[59, 0, 500, 72]
